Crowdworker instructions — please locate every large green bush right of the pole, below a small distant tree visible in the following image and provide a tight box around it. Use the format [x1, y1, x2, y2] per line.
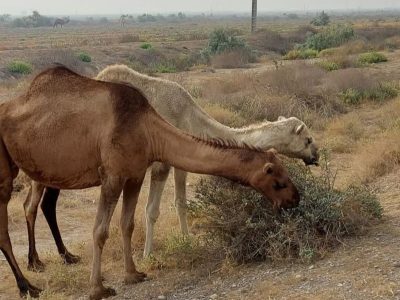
[303, 25, 354, 51]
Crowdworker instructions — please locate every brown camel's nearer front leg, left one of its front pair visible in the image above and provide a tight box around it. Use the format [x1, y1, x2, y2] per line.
[90, 168, 125, 300]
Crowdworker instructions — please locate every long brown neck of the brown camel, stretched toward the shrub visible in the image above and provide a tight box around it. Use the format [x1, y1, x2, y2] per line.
[147, 114, 257, 184]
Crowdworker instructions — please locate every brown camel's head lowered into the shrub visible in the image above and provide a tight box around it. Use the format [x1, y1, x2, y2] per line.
[249, 149, 300, 210]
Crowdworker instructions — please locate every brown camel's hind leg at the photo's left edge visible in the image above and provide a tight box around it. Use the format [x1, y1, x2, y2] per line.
[0, 143, 40, 297]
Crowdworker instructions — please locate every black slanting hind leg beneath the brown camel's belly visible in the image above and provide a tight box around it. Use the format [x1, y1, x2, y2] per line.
[40, 187, 80, 264]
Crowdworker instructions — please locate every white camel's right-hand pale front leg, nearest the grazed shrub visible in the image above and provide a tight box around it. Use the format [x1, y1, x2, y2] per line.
[174, 168, 189, 235]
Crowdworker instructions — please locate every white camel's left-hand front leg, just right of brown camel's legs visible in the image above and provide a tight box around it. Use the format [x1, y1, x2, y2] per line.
[143, 163, 170, 257]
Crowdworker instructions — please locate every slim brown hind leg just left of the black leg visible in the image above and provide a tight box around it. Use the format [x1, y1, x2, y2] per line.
[24, 181, 45, 272]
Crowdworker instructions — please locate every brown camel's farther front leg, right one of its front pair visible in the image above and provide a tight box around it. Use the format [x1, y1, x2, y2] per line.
[121, 175, 146, 284]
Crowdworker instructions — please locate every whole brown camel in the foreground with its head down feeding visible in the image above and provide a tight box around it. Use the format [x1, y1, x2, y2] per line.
[0, 66, 300, 299]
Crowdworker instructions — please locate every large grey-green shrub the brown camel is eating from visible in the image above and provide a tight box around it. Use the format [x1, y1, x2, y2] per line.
[193, 152, 382, 262]
